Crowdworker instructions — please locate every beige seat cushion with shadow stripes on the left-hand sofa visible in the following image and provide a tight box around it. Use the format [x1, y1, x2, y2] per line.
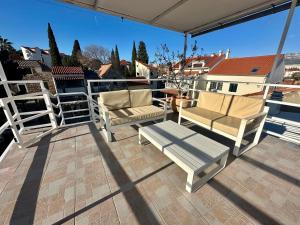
[109, 105, 164, 126]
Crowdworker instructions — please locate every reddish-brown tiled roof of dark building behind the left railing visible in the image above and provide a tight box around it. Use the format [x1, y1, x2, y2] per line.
[52, 66, 84, 80]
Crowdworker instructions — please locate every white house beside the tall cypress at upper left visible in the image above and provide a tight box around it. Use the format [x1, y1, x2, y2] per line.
[21, 46, 52, 67]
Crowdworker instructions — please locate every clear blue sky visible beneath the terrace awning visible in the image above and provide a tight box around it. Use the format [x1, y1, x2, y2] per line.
[0, 0, 300, 60]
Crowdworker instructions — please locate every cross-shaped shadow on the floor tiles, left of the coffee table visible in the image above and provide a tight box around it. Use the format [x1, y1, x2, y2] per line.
[55, 123, 173, 225]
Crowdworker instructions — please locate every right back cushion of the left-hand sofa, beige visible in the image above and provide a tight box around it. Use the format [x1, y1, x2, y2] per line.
[129, 89, 152, 107]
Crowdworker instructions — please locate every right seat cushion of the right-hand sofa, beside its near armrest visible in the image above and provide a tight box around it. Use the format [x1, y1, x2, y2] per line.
[212, 116, 259, 137]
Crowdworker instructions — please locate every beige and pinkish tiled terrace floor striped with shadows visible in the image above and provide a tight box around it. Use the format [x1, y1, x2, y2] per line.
[0, 118, 300, 225]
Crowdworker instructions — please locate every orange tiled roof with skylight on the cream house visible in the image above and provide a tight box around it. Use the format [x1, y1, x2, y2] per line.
[208, 55, 283, 76]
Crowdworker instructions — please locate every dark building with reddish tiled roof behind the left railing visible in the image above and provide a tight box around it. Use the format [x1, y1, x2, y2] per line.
[52, 66, 86, 93]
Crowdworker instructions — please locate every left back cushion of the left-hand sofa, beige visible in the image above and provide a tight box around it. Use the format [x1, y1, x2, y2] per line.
[99, 90, 130, 110]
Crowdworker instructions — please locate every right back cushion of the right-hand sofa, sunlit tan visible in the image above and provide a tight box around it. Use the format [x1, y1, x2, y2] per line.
[228, 96, 265, 119]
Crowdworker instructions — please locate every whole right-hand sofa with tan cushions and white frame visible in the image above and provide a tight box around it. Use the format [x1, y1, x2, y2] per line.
[178, 91, 269, 156]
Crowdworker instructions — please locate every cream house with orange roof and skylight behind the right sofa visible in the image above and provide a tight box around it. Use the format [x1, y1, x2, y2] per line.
[203, 55, 284, 95]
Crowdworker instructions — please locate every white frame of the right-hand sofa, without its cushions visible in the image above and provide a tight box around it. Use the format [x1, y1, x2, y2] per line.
[178, 99, 269, 157]
